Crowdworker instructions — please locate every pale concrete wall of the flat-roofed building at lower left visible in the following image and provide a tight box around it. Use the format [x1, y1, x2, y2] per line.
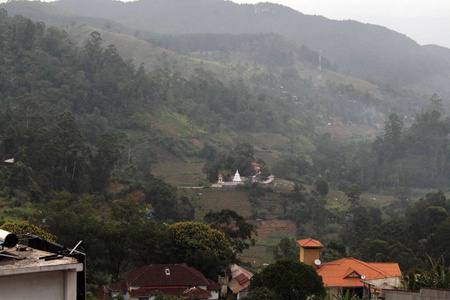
[0, 271, 77, 300]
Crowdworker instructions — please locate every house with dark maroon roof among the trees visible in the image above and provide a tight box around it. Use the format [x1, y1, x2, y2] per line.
[105, 264, 220, 300]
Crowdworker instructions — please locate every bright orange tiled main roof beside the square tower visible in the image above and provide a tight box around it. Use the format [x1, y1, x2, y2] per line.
[316, 257, 402, 287]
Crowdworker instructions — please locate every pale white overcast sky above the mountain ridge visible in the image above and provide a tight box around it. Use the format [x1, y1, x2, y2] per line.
[0, 0, 450, 48]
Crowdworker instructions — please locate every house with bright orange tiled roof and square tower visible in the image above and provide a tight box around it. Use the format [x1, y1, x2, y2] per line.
[297, 239, 402, 299]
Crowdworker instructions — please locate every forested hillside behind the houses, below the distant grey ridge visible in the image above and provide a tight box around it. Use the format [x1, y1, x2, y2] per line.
[0, 8, 450, 298]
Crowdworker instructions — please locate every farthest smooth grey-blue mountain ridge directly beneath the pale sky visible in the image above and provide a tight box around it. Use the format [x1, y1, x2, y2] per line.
[4, 0, 450, 101]
